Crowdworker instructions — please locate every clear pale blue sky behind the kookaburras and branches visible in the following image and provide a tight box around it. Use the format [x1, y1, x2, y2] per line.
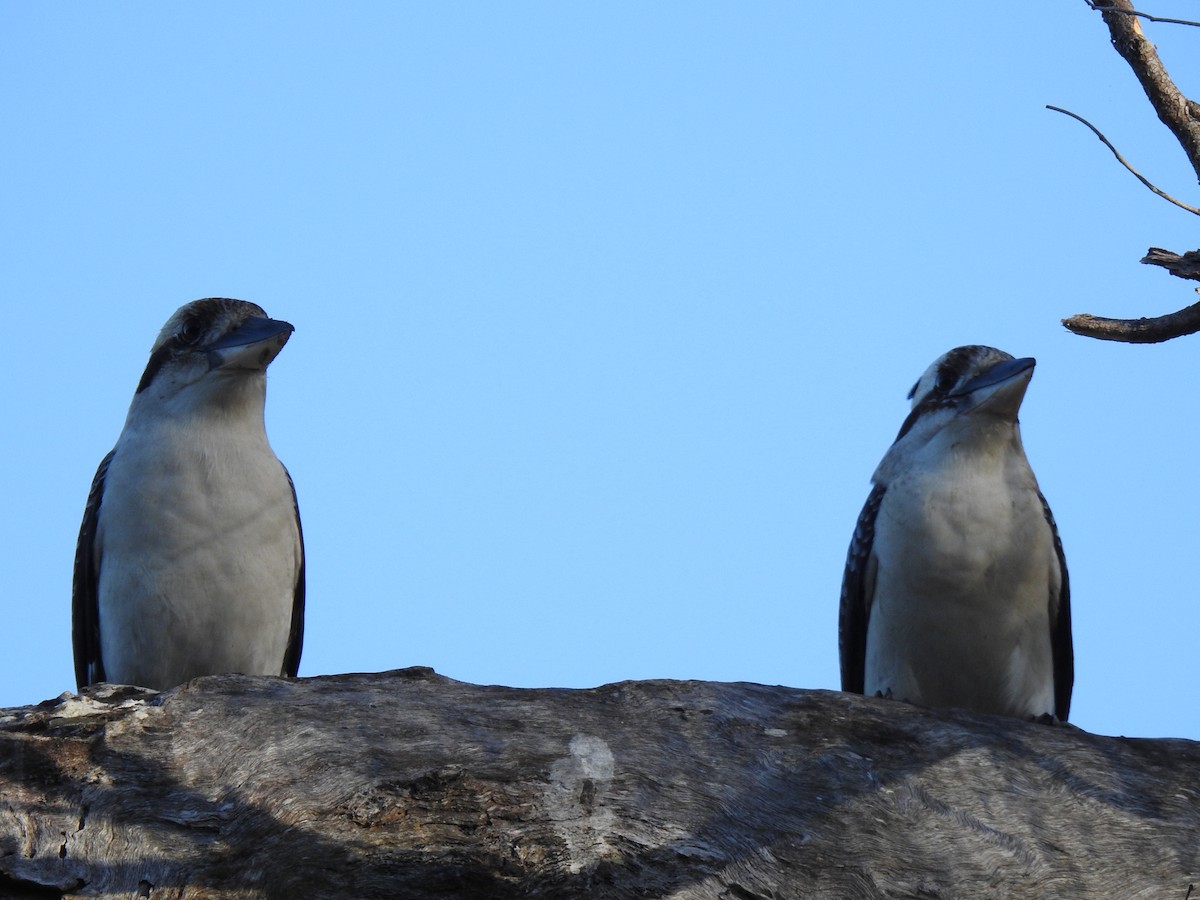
[0, 0, 1200, 738]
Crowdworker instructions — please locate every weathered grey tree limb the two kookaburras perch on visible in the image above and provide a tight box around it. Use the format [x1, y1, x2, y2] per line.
[0, 668, 1200, 900]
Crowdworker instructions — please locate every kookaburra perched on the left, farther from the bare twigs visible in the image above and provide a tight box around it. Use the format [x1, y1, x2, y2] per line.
[72, 298, 305, 689]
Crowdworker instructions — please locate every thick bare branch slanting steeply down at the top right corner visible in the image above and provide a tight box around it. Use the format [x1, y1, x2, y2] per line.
[1088, 0, 1200, 178]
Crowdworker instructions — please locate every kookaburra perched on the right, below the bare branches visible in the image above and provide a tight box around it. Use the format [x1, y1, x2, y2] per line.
[839, 346, 1074, 721]
